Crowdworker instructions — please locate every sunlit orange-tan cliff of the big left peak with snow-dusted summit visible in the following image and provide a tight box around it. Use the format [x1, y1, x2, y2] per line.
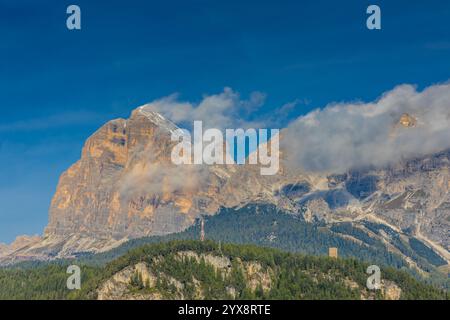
[45, 108, 225, 238]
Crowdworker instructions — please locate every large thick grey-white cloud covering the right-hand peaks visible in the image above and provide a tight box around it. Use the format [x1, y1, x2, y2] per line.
[281, 83, 450, 173]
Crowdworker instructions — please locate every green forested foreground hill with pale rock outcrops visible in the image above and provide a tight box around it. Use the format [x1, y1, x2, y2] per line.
[0, 241, 447, 299]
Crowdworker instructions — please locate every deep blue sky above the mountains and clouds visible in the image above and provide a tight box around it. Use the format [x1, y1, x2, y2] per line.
[0, 0, 450, 242]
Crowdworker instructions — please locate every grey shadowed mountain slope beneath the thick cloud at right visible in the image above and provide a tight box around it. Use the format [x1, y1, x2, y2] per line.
[299, 151, 450, 255]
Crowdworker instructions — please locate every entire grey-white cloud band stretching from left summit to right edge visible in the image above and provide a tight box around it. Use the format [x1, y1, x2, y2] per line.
[141, 83, 450, 173]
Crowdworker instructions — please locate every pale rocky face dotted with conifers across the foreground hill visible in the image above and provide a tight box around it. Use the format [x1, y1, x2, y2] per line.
[92, 245, 408, 300]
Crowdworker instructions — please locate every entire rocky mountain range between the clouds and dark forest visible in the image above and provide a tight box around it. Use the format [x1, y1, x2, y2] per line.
[0, 106, 450, 270]
